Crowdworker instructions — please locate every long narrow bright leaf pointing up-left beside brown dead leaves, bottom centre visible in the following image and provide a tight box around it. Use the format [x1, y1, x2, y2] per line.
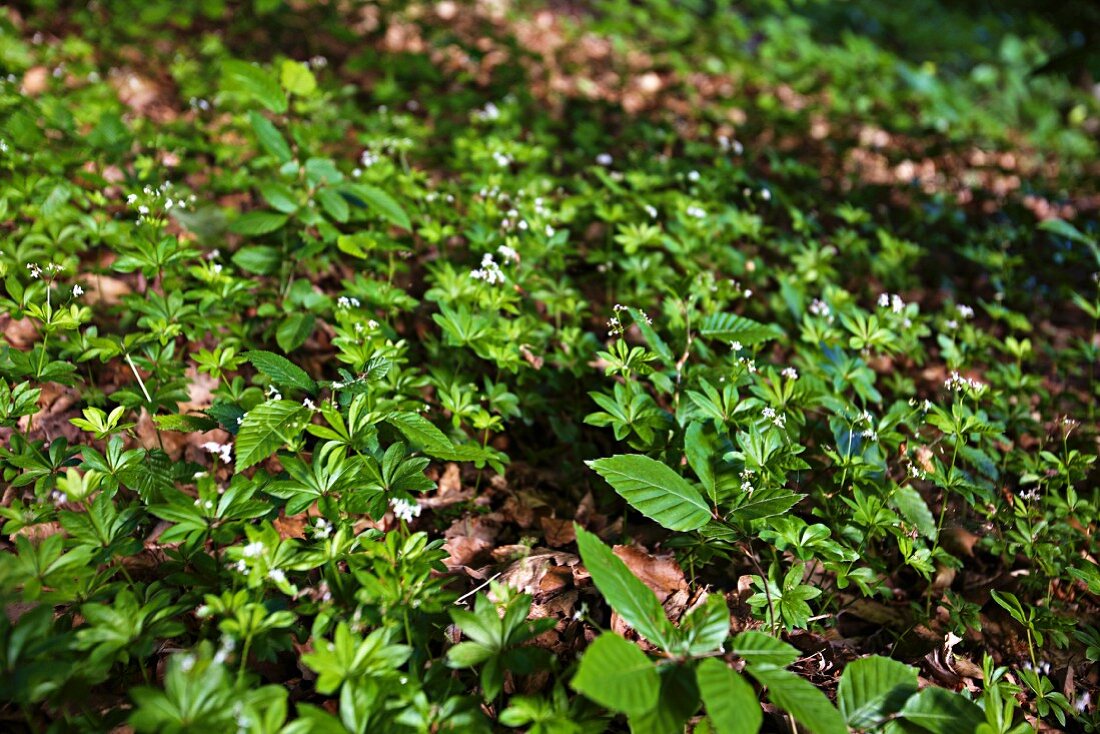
[574, 525, 675, 649]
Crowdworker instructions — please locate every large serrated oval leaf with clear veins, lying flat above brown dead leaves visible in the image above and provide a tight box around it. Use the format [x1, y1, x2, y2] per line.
[587, 453, 711, 532]
